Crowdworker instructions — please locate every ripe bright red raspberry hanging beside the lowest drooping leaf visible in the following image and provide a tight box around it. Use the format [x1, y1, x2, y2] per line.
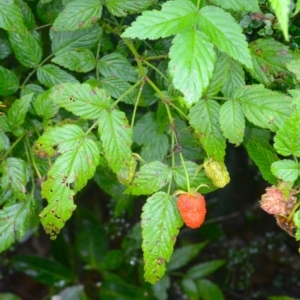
[177, 193, 206, 228]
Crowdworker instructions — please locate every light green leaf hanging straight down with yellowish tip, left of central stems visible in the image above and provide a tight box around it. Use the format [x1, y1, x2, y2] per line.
[98, 109, 132, 178]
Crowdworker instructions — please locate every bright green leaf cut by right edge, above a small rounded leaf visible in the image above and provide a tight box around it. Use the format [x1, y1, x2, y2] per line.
[274, 110, 300, 157]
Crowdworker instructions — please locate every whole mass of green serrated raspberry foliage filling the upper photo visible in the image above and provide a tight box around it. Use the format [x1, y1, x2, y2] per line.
[0, 0, 300, 294]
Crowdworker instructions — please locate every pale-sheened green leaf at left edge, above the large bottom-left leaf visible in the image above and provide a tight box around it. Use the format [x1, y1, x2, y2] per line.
[0, 157, 30, 200]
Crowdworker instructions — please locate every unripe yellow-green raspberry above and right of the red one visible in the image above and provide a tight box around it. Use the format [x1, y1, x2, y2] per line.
[203, 159, 230, 188]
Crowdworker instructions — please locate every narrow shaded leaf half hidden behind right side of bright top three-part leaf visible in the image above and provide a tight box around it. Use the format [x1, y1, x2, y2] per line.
[205, 52, 231, 98]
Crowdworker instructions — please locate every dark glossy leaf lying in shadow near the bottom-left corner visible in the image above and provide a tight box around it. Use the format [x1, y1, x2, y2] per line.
[13, 255, 76, 287]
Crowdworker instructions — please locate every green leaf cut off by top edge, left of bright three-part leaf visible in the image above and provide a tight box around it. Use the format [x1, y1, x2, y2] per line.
[105, 0, 157, 17]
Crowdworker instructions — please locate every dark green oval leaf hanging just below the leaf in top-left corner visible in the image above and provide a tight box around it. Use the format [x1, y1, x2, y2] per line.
[8, 31, 43, 68]
